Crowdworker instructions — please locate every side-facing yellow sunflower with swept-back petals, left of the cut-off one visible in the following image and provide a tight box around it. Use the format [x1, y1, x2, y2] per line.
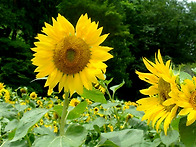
[136, 50, 178, 134]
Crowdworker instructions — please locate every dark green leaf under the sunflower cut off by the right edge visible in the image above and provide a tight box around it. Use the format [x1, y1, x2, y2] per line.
[179, 117, 196, 147]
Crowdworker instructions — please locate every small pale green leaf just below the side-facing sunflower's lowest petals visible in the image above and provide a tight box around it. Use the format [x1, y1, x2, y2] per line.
[160, 130, 179, 146]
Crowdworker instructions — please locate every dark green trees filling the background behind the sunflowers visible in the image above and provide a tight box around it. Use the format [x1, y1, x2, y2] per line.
[0, 0, 196, 100]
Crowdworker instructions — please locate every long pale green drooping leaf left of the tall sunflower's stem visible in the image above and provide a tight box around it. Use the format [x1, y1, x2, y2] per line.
[12, 108, 49, 141]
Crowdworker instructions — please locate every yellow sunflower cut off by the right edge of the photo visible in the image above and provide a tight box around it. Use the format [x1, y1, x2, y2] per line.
[177, 77, 196, 126]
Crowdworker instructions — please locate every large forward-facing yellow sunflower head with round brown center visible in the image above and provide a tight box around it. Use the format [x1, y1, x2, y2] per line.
[32, 14, 113, 94]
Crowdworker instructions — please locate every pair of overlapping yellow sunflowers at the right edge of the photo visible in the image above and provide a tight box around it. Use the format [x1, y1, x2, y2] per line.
[136, 50, 196, 134]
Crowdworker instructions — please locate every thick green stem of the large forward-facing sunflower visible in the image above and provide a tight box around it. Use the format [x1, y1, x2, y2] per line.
[60, 92, 69, 136]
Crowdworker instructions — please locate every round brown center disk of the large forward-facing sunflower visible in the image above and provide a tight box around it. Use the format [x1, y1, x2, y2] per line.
[53, 36, 91, 74]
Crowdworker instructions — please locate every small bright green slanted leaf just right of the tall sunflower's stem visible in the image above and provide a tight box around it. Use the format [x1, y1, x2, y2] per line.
[67, 101, 87, 119]
